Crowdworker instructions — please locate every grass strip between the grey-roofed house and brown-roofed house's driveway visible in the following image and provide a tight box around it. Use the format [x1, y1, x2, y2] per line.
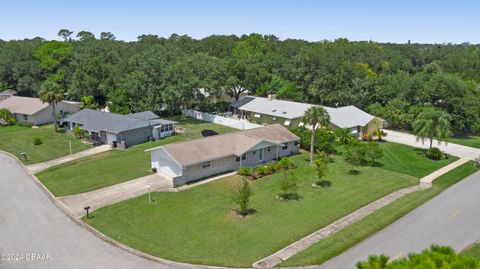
[36, 117, 235, 197]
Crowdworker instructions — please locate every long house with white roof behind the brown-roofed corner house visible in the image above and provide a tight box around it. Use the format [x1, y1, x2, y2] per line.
[231, 95, 384, 137]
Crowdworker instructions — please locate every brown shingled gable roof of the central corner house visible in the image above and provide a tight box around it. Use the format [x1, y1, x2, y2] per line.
[147, 124, 299, 167]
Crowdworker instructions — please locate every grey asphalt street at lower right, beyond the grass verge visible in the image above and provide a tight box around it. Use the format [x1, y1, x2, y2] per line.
[320, 172, 480, 269]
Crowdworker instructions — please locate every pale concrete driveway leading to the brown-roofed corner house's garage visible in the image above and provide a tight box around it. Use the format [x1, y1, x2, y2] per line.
[57, 173, 177, 218]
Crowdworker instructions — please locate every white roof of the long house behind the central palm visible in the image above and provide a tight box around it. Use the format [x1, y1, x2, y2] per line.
[239, 96, 375, 128]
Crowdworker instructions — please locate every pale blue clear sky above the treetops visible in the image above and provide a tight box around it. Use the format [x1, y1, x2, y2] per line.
[0, 0, 480, 44]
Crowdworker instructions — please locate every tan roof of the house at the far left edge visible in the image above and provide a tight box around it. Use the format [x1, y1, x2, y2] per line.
[0, 95, 49, 115]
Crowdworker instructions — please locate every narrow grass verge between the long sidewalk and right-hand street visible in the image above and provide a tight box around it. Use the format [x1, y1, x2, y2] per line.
[281, 162, 480, 267]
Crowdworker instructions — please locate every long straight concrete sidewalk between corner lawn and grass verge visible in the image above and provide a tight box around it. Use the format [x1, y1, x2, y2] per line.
[253, 158, 469, 268]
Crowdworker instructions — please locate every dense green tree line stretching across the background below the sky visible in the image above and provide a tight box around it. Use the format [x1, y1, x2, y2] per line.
[0, 29, 480, 134]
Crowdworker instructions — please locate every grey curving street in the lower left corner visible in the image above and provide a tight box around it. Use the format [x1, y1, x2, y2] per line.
[0, 153, 171, 269]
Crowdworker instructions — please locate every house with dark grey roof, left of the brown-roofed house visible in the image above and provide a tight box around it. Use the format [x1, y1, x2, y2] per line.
[62, 109, 177, 148]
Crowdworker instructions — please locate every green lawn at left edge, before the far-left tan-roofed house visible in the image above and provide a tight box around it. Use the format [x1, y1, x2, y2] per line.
[0, 124, 91, 164]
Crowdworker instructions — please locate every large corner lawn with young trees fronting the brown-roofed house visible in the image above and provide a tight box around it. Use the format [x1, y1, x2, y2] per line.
[83, 153, 418, 266]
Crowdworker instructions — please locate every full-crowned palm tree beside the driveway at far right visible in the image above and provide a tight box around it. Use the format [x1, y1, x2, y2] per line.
[412, 107, 452, 148]
